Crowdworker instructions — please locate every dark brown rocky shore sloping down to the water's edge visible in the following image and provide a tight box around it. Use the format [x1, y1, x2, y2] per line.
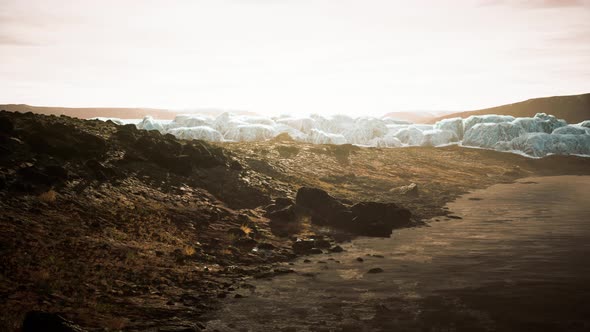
[0, 112, 590, 331]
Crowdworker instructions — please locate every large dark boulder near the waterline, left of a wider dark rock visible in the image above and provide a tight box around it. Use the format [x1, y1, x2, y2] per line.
[295, 187, 347, 225]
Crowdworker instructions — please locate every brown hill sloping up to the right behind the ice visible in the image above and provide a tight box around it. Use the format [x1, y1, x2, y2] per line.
[428, 93, 590, 123]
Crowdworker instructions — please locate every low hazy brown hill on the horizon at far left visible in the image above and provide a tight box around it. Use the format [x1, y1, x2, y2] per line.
[0, 104, 177, 120]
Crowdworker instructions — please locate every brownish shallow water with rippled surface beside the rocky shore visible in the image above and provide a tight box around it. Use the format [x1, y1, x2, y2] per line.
[207, 176, 590, 331]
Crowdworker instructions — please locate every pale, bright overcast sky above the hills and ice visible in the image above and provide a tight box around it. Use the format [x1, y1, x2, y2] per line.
[0, 0, 590, 115]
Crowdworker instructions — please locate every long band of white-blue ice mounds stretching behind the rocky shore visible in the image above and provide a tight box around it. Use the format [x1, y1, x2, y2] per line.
[98, 112, 590, 157]
